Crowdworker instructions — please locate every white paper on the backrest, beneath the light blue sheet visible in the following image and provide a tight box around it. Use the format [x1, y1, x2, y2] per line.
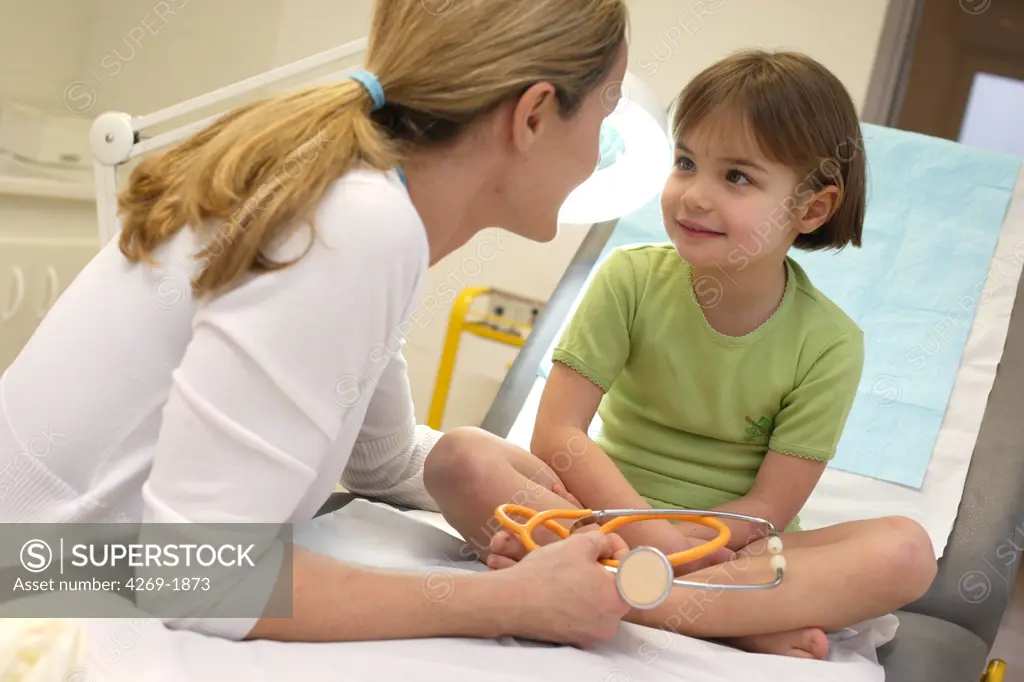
[516, 164, 1024, 556]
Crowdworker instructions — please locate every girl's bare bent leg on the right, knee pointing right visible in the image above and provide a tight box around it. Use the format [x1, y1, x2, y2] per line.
[630, 517, 936, 638]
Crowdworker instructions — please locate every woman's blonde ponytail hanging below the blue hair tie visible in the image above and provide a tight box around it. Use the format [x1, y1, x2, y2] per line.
[120, 80, 397, 296]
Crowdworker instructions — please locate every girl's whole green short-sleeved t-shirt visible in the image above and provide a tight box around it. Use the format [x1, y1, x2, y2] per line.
[552, 244, 863, 530]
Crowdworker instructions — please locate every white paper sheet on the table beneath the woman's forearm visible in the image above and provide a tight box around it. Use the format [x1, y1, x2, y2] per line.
[64, 501, 895, 682]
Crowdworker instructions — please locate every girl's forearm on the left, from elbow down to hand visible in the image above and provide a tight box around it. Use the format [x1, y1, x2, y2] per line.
[531, 427, 692, 554]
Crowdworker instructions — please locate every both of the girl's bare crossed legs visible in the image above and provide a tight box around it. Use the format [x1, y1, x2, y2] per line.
[424, 430, 936, 657]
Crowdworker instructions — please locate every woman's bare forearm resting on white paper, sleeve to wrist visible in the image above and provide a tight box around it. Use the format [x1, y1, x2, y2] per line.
[248, 547, 507, 642]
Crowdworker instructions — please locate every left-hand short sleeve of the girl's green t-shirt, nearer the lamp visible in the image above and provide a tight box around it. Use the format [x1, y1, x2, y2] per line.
[552, 249, 637, 392]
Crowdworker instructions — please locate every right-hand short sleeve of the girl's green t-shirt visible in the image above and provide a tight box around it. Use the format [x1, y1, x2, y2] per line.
[768, 330, 864, 462]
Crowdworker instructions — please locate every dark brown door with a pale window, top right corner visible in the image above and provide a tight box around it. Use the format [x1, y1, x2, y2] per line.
[894, 0, 1024, 144]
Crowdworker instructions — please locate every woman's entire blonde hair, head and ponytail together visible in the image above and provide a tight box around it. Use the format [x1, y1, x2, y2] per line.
[119, 0, 628, 296]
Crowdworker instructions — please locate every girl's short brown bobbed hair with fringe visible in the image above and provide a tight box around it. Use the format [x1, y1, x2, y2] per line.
[672, 50, 867, 251]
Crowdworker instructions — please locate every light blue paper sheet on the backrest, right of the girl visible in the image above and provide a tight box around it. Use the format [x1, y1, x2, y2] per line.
[793, 129, 1021, 487]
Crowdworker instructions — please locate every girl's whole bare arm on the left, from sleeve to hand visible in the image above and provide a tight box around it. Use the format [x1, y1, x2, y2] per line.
[530, 363, 702, 570]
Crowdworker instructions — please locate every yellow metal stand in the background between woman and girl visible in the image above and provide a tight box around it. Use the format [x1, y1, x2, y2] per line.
[427, 287, 543, 430]
